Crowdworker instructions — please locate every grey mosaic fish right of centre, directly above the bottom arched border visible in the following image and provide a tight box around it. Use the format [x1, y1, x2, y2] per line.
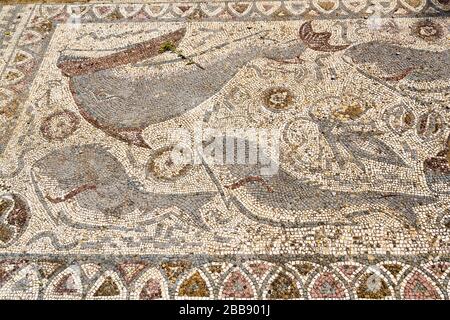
[202, 139, 438, 228]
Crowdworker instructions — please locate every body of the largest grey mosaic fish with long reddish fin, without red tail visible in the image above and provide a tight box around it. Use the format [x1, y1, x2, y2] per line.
[58, 28, 304, 148]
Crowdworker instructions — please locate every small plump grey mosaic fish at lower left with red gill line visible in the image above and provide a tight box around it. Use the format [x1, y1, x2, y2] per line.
[33, 144, 216, 229]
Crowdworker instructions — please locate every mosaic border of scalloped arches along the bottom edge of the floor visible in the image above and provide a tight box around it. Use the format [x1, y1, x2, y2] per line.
[0, 255, 450, 300]
